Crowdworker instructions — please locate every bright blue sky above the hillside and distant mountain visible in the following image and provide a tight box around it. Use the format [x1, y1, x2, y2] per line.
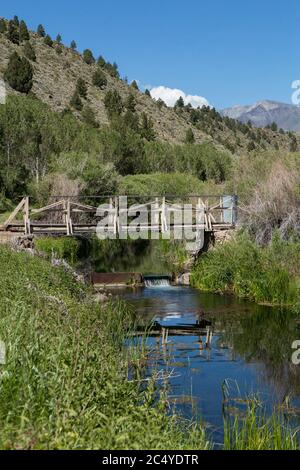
[0, 0, 300, 108]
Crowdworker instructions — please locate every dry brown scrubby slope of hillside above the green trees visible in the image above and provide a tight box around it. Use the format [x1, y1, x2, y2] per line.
[0, 17, 300, 154]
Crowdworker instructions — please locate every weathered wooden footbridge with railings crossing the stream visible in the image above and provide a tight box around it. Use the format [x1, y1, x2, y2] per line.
[0, 195, 237, 238]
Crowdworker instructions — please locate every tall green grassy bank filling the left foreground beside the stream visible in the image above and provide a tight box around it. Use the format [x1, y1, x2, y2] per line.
[0, 247, 207, 449]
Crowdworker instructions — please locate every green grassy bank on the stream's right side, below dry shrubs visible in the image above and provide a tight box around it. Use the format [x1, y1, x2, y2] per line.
[191, 233, 300, 309]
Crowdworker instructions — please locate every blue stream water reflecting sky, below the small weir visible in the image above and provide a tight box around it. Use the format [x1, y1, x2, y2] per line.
[113, 279, 300, 442]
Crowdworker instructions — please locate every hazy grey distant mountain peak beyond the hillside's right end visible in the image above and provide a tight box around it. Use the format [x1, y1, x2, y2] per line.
[220, 100, 300, 132]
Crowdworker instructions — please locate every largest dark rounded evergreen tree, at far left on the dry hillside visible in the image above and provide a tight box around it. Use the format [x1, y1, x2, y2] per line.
[4, 52, 33, 93]
